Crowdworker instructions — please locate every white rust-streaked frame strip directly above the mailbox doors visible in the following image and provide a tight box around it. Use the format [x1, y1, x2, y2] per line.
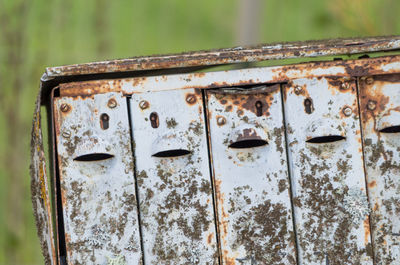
[60, 56, 400, 96]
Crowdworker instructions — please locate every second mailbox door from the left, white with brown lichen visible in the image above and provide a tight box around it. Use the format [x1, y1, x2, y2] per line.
[130, 89, 218, 264]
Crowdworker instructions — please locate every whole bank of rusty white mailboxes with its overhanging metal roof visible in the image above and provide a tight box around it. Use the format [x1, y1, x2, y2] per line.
[31, 36, 400, 265]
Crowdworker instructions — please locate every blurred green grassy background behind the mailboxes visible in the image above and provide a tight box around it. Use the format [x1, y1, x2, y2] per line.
[0, 0, 400, 265]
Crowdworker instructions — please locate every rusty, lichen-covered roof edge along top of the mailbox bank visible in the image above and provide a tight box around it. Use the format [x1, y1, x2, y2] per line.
[46, 36, 400, 79]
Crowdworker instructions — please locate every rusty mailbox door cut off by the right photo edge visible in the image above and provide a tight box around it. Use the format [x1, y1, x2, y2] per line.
[359, 75, 400, 265]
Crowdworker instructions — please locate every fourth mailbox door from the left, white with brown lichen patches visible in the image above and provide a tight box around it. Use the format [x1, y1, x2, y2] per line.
[284, 78, 372, 265]
